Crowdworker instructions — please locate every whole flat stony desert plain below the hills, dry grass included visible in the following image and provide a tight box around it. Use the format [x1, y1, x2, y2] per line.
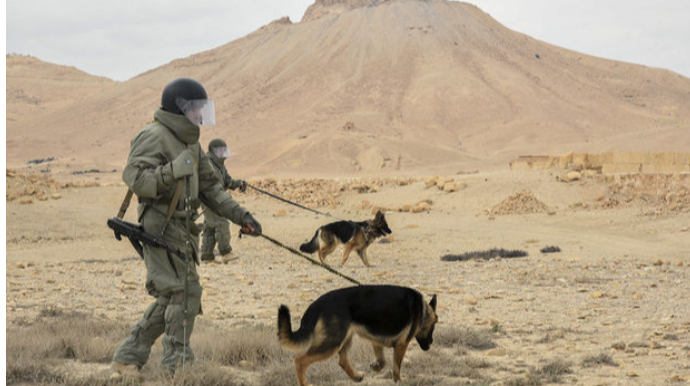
[5, 171, 690, 386]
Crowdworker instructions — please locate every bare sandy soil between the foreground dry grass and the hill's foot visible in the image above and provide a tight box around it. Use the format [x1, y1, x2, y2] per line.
[5, 172, 690, 386]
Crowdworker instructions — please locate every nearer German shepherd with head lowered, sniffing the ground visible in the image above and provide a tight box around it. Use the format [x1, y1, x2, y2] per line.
[278, 285, 438, 386]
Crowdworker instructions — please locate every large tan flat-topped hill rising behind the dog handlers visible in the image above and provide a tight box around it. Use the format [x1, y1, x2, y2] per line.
[7, 0, 690, 175]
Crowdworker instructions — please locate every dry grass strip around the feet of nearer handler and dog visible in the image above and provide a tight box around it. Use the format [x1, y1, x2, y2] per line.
[5, 307, 494, 386]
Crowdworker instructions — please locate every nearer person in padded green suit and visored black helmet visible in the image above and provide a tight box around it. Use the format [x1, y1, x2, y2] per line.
[112, 78, 261, 379]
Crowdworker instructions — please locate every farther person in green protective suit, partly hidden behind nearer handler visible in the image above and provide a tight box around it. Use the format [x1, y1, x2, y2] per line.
[201, 138, 247, 261]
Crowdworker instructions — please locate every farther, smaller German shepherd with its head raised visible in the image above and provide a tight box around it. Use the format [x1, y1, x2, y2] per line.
[299, 211, 393, 267]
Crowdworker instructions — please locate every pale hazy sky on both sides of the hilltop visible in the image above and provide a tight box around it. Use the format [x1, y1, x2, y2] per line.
[5, 0, 690, 80]
